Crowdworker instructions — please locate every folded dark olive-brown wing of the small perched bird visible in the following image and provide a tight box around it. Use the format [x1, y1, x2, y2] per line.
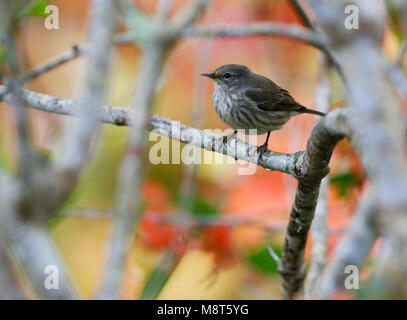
[245, 80, 302, 111]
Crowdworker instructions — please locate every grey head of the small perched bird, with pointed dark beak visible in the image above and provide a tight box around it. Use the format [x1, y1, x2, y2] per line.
[201, 64, 251, 88]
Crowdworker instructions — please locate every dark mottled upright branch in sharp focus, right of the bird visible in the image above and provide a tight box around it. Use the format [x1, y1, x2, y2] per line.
[279, 109, 351, 299]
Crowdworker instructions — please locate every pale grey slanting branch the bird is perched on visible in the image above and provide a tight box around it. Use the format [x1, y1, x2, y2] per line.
[0, 85, 303, 178]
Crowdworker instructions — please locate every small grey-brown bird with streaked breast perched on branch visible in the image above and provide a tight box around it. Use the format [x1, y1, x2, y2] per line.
[201, 64, 325, 154]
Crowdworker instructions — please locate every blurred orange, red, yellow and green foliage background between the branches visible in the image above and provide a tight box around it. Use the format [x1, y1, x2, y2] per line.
[0, 0, 400, 299]
